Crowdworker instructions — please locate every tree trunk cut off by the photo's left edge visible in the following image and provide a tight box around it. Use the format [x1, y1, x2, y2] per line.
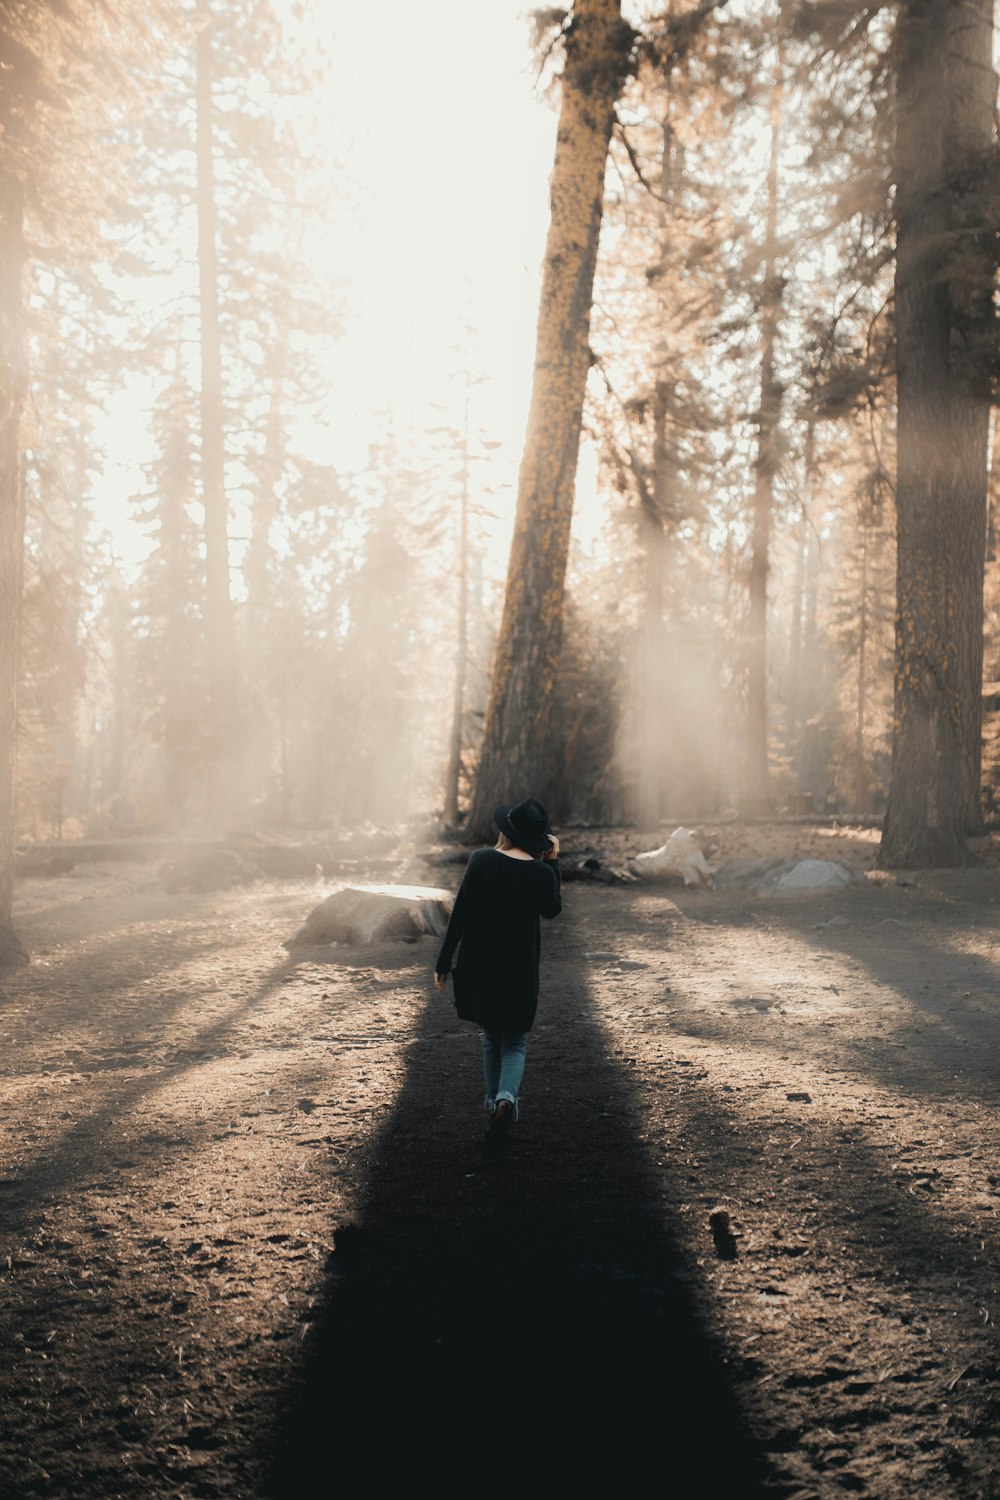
[0, 168, 27, 969]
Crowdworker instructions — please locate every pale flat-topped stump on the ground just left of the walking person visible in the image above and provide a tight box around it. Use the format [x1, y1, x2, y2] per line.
[283, 885, 451, 948]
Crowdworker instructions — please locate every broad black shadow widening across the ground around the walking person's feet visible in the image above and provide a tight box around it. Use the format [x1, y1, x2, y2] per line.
[265, 939, 775, 1500]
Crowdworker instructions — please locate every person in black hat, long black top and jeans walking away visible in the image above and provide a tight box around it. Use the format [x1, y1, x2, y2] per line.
[435, 798, 562, 1148]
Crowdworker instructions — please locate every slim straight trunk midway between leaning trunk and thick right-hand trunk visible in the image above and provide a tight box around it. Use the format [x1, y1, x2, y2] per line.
[741, 57, 783, 813]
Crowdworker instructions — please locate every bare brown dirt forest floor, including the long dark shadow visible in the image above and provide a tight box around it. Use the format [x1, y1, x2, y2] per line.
[0, 825, 1000, 1500]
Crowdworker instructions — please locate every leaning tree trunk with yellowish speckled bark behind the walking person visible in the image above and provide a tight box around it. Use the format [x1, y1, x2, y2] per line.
[468, 0, 631, 839]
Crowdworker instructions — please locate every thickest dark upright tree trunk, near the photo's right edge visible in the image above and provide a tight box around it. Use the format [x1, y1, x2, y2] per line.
[879, 0, 996, 869]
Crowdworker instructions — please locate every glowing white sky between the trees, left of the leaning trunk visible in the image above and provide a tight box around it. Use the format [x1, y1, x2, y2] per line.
[97, 0, 556, 564]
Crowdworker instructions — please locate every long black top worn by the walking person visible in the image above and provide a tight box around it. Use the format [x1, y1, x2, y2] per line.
[435, 849, 562, 1032]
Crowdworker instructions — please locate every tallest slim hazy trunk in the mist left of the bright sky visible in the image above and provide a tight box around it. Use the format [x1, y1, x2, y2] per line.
[196, 0, 237, 815]
